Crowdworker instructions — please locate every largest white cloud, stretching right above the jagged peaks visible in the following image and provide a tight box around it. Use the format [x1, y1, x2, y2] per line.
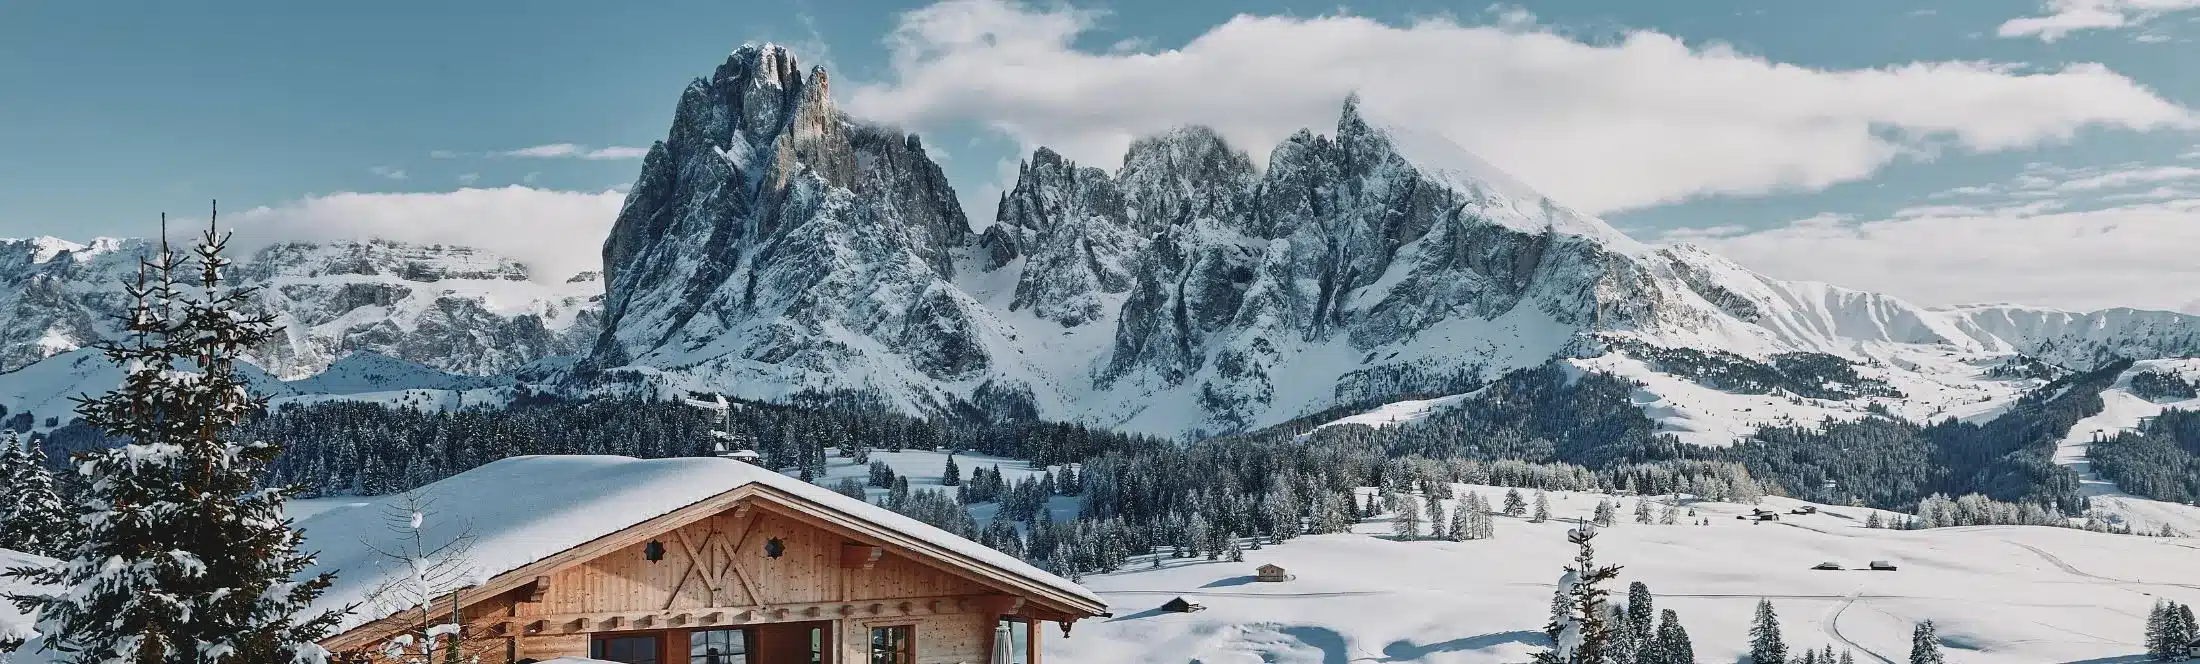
[847, 0, 2200, 211]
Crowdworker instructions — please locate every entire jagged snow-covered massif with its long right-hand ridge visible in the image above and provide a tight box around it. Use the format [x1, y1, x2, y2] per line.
[576, 46, 2200, 435]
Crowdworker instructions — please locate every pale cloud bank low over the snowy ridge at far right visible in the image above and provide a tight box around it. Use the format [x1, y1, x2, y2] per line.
[1668, 198, 2200, 310]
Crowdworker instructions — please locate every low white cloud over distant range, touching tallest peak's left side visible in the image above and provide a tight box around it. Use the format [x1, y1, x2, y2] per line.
[224, 187, 625, 281]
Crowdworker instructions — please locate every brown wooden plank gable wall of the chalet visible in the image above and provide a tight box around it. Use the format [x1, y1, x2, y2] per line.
[343, 497, 1082, 664]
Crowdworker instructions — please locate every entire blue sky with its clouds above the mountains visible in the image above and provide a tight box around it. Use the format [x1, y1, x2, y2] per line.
[0, 0, 2200, 310]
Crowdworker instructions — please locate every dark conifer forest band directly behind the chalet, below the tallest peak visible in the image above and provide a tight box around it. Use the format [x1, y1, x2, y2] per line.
[40, 398, 1168, 497]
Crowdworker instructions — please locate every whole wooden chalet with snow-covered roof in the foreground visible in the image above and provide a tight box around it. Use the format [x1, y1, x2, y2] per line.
[299, 457, 1107, 664]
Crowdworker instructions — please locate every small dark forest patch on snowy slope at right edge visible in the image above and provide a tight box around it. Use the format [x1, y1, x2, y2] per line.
[2088, 406, 2200, 503]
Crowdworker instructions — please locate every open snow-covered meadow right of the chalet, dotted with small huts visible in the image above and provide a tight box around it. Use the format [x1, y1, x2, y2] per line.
[1047, 486, 2200, 664]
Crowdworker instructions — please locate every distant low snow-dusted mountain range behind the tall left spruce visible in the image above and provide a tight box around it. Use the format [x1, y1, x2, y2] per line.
[0, 237, 601, 380]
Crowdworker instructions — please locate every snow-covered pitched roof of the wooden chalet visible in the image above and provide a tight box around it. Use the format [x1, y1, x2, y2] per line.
[297, 455, 1104, 631]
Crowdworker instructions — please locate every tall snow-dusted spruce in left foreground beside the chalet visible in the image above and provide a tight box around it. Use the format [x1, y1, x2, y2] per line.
[9, 214, 341, 664]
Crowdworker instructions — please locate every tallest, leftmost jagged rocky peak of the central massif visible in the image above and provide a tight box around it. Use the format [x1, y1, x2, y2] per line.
[581, 44, 988, 384]
